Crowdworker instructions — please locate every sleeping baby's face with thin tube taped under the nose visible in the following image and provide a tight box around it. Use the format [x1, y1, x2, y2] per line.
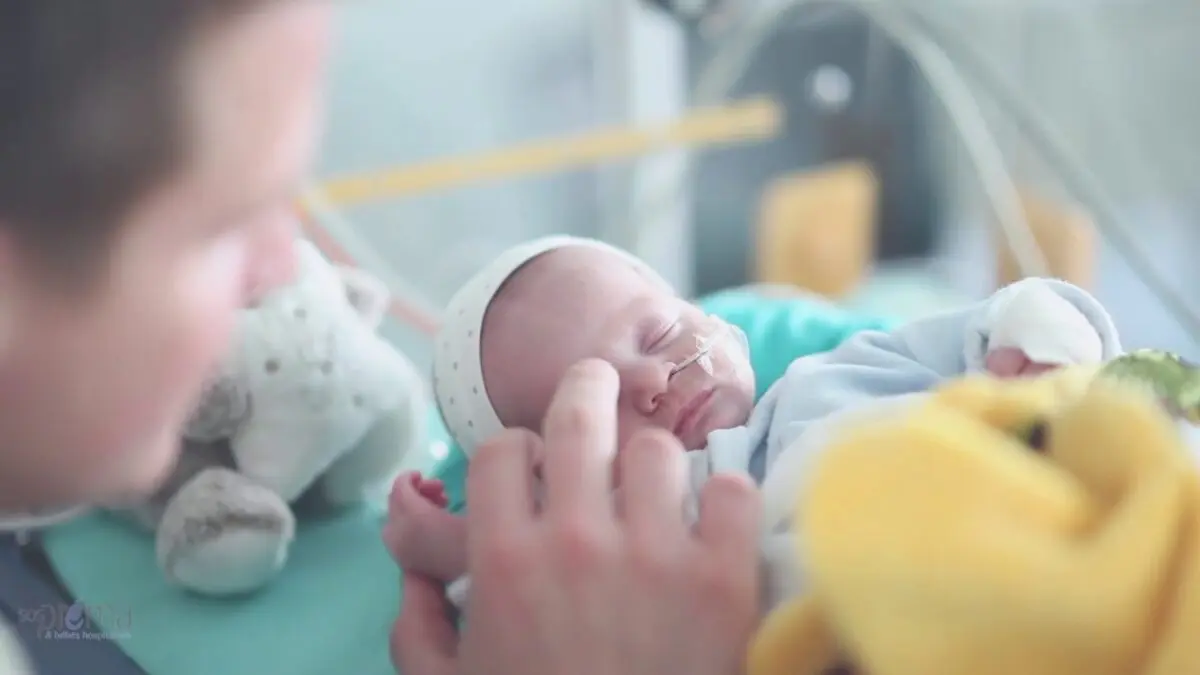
[482, 246, 754, 449]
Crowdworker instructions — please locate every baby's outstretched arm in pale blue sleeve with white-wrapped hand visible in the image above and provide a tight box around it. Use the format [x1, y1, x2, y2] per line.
[762, 279, 1121, 526]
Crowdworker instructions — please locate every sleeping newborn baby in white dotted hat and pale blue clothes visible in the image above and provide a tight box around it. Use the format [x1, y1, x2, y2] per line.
[384, 238, 1120, 605]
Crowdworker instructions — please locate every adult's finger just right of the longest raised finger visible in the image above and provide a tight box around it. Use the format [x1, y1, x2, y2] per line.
[617, 430, 688, 537]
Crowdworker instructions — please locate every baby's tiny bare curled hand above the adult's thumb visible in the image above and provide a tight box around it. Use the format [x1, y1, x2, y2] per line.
[383, 471, 452, 569]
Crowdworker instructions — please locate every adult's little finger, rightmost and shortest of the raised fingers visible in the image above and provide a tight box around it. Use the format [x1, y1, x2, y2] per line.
[696, 473, 762, 565]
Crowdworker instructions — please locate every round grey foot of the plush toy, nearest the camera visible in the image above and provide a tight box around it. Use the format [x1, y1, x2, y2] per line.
[157, 468, 295, 596]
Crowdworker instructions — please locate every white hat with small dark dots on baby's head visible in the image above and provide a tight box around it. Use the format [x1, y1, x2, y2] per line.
[433, 235, 668, 456]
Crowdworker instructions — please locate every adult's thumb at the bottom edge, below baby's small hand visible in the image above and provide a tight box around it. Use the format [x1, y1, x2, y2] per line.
[389, 573, 458, 675]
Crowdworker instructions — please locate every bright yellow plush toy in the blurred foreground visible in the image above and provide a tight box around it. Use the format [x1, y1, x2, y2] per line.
[748, 355, 1200, 675]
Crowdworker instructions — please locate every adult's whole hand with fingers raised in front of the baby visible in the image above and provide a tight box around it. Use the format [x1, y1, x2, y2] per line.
[392, 362, 760, 675]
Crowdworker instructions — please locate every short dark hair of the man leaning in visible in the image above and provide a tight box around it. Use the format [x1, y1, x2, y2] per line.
[0, 0, 264, 277]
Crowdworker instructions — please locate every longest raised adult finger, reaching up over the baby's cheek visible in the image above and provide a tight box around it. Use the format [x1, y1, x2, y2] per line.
[542, 359, 620, 519]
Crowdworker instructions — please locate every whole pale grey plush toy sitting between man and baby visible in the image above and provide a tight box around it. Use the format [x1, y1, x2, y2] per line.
[124, 240, 430, 596]
